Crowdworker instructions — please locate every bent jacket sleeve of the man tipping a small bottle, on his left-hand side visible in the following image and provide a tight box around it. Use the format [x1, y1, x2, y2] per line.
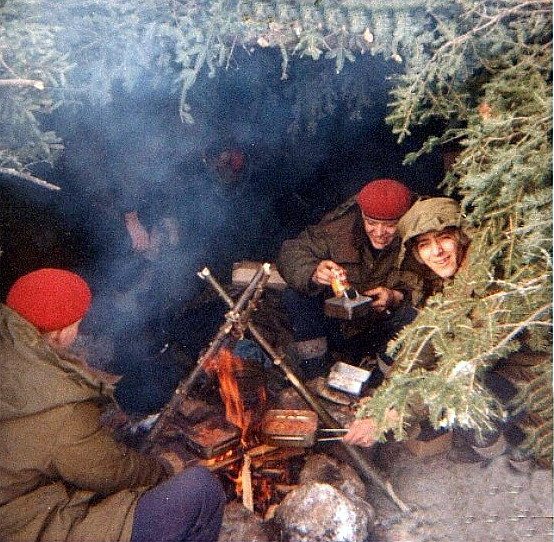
[276, 226, 330, 294]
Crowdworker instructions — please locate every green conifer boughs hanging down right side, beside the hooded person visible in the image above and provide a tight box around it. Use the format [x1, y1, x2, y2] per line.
[359, 0, 552, 468]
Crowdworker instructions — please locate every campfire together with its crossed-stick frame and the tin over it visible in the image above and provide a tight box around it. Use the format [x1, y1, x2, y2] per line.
[136, 264, 407, 518]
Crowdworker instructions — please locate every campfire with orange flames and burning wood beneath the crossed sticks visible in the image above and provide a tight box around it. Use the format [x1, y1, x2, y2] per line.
[142, 348, 308, 518]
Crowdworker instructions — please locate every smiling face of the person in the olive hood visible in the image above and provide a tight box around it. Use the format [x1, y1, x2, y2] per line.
[415, 230, 463, 279]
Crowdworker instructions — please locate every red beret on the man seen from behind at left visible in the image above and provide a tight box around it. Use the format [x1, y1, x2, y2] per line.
[6, 269, 92, 331]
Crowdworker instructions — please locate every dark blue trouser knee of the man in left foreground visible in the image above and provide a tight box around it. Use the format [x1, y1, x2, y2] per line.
[131, 467, 225, 542]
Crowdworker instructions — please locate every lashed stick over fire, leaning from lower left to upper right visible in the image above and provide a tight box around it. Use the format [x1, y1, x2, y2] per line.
[142, 264, 269, 450]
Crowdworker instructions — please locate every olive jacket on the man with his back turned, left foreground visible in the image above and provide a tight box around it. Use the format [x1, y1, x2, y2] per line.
[0, 305, 168, 542]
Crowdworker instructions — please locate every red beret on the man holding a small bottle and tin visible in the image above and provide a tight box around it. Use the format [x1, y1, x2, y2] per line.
[357, 179, 412, 220]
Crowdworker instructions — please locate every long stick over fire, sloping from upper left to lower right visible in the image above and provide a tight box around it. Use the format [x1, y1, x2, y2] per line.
[198, 269, 409, 512]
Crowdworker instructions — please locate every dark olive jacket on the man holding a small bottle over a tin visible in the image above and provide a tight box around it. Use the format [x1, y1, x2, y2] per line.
[276, 199, 421, 304]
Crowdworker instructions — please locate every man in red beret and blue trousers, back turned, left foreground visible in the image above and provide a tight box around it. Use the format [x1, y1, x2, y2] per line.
[0, 269, 225, 542]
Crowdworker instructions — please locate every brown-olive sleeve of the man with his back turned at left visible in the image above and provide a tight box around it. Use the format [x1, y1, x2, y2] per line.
[52, 401, 171, 494]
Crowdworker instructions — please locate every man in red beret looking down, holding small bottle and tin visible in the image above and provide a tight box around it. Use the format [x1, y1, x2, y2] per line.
[277, 179, 418, 376]
